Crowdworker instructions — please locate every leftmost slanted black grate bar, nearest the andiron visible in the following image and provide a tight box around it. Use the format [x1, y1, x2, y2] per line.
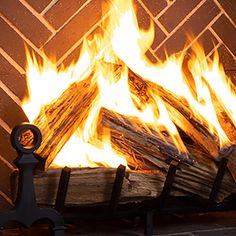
[55, 167, 71, 213]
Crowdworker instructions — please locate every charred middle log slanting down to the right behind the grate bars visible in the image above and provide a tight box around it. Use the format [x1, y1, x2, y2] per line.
[100, 109, 236, 201]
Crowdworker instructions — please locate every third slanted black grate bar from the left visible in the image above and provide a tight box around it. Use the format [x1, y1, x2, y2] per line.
[156, 160, 179, 210]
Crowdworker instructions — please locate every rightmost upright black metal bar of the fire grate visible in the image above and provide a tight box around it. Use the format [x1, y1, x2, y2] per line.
[209, 157, 228, 204]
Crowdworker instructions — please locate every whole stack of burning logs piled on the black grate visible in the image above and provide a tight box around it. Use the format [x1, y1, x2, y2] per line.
[30, 61, 236, 205]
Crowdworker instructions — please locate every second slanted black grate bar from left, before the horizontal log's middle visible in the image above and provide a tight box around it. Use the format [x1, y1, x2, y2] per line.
[109, 165, 126, 213]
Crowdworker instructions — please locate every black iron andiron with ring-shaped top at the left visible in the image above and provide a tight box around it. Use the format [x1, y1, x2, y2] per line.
[0, 124, 65, 236]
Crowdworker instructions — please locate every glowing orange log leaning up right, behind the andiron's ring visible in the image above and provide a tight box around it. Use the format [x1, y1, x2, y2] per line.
[33, 74, 98, 168]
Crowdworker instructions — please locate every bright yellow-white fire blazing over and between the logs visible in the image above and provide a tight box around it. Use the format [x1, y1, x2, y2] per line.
[23, 0, 236, 167]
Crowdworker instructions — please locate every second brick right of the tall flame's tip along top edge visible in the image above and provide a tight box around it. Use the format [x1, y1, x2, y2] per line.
[159, 0, 201, 33]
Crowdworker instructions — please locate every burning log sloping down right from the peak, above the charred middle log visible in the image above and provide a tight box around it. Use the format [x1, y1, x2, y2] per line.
[129, 71, 219, 158]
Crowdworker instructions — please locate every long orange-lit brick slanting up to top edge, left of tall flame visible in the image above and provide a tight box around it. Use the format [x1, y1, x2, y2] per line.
[44, 0, 106, 59]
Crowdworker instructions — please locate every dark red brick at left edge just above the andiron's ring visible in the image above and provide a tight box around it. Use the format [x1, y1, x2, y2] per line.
[0, 88, 28, 128]
